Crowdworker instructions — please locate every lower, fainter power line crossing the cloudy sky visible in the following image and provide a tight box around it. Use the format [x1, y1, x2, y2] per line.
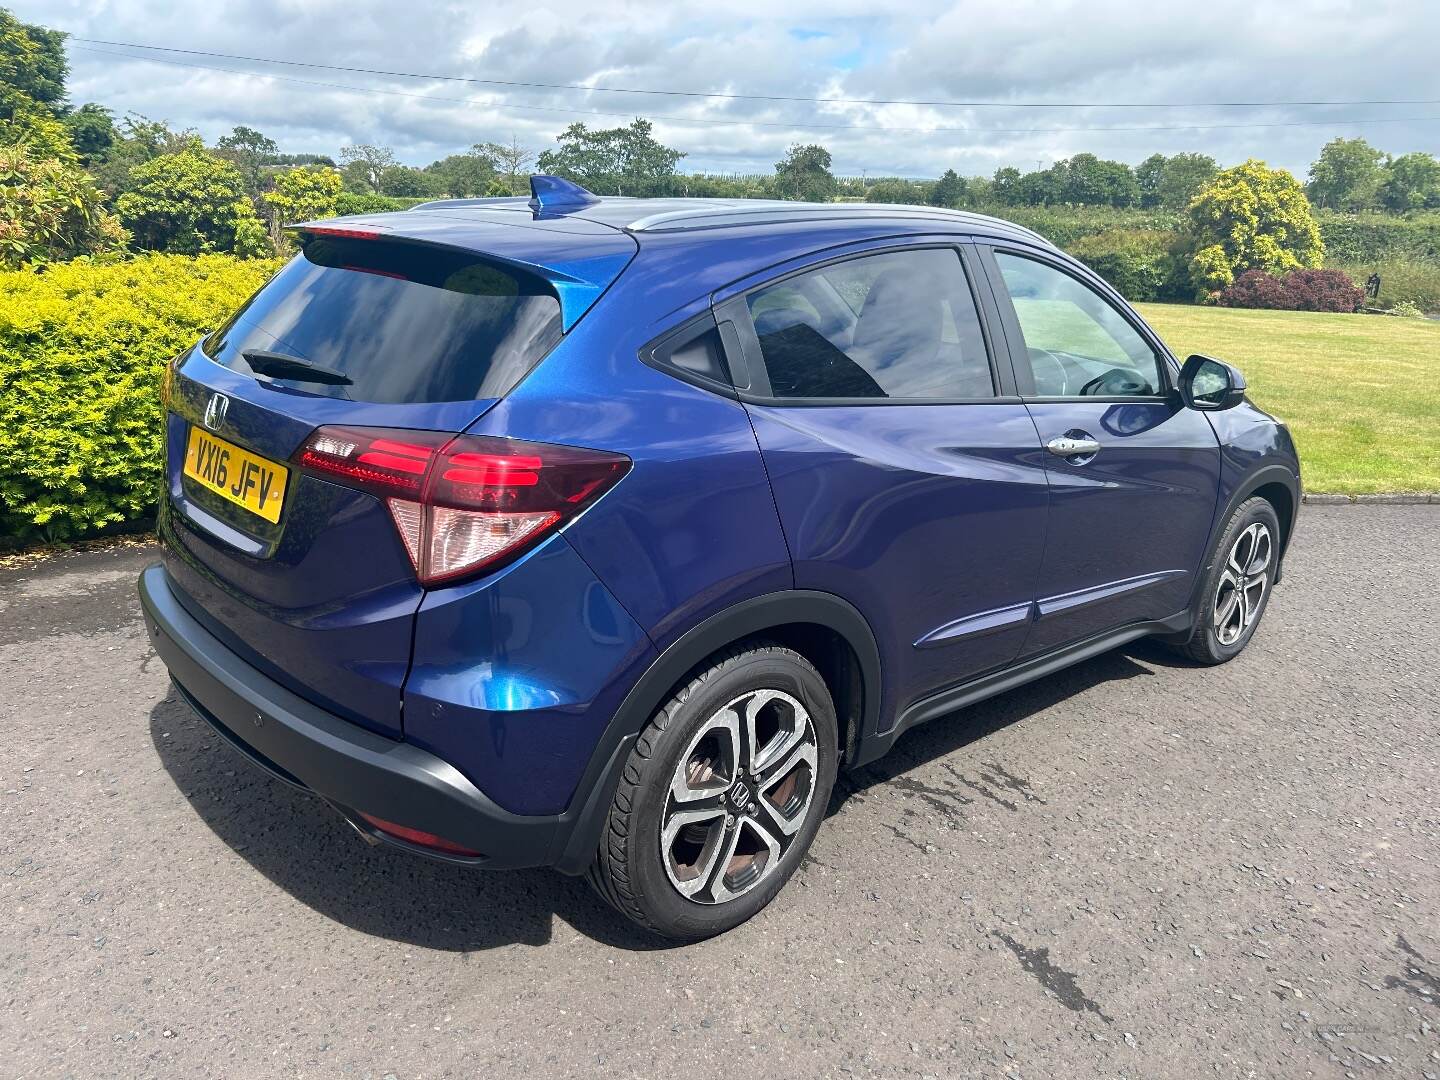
[71, 39, 1440, 135]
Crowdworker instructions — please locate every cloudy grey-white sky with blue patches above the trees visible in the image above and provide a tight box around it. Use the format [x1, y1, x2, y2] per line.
[19, 0, 1440, 177]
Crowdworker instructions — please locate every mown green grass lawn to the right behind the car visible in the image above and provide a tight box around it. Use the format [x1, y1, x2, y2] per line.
[1136, 304, 1440, 494]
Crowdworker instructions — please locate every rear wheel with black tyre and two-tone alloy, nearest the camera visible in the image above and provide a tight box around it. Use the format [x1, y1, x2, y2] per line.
[589, 642, 838, 940]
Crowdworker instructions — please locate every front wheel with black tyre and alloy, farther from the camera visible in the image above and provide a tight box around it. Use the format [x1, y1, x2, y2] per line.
[1175, 498, 1280, 664]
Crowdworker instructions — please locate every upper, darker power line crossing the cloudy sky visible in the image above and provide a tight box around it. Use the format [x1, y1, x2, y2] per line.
[69, 36, 1440, 109]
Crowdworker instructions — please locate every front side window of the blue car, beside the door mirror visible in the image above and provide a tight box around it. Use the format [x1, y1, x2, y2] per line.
[995, 252, 1164, 397]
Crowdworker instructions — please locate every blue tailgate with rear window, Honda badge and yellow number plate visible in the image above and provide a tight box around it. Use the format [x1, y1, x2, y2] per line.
[160, 230, 578, 734]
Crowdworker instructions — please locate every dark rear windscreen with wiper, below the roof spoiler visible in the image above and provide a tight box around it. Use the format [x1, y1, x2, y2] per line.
[204, 236, 562, 403]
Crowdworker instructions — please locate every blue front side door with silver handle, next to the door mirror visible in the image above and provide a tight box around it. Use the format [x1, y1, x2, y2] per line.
[981, 246, 1220, 655]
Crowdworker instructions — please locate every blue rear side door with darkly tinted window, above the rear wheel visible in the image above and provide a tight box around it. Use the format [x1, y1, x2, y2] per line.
[717, 242, 1047, 714]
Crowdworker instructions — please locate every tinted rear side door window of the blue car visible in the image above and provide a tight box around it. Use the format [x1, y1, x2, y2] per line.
[746, 248, 994, 399]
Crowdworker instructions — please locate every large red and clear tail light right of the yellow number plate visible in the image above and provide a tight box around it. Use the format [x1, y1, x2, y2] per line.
[294, 428, 631, 585]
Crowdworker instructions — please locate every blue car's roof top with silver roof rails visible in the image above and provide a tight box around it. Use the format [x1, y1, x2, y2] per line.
[402, 196, 1054, 248]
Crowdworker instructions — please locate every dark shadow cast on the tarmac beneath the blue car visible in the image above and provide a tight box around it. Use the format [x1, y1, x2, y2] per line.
[150, 642, 1182, 952]
